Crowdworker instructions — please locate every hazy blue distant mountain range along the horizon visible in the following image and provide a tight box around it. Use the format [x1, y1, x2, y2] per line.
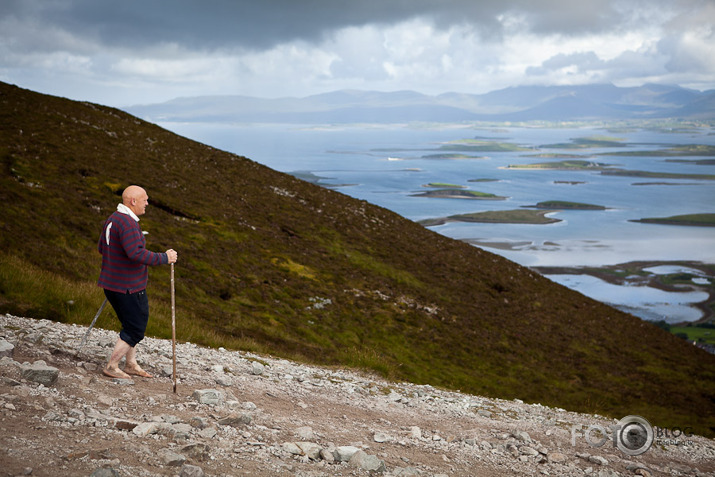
[125, 84, 715, 124]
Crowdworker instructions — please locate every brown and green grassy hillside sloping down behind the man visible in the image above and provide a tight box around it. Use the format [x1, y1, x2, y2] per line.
[0, 83, 715, 435]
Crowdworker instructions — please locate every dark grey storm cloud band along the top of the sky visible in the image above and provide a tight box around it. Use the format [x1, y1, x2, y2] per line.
[0, 0, 644, 50]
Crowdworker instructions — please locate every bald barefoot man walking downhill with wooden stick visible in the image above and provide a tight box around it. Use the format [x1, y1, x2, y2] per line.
[97, 185, 177, 379]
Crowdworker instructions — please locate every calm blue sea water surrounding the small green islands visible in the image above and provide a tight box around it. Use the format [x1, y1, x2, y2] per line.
[161, 123, 715, 321]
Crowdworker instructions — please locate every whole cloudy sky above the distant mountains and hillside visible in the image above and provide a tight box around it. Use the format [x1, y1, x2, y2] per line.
[0, 0, 715, 107]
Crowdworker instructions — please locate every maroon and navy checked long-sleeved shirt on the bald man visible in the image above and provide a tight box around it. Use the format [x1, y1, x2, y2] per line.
[97, 212, 169, 293]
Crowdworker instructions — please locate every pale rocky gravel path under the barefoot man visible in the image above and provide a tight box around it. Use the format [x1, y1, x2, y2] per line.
[0, 315, 715, 477]
